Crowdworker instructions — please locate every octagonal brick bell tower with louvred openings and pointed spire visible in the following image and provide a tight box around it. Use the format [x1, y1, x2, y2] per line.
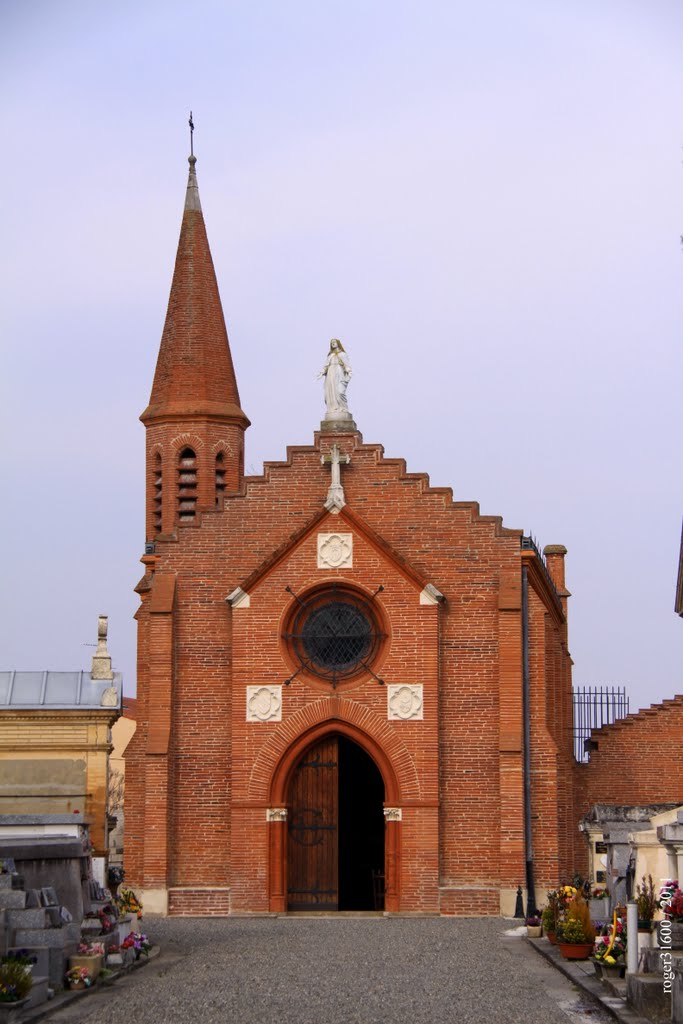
[140, 153, 249, 541]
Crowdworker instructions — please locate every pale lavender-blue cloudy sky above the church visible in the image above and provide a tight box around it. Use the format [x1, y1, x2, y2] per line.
[0, 0, 683, 710]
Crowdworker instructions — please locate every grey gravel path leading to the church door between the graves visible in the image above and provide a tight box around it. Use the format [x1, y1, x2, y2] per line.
[49, 918, 611, 1024]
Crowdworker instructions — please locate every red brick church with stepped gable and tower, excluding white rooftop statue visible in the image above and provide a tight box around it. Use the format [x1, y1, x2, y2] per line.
[125, 158, 579, 914]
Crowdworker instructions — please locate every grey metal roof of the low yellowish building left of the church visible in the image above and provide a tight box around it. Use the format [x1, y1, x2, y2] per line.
[0, 672, 123, 711]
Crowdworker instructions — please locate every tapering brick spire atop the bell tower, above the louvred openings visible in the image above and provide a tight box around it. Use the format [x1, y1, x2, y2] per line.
[140, 155, 249, 428]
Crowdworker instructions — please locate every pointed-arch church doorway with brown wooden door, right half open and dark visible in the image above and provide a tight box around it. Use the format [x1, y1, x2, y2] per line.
[287, 735, 385, 910]
